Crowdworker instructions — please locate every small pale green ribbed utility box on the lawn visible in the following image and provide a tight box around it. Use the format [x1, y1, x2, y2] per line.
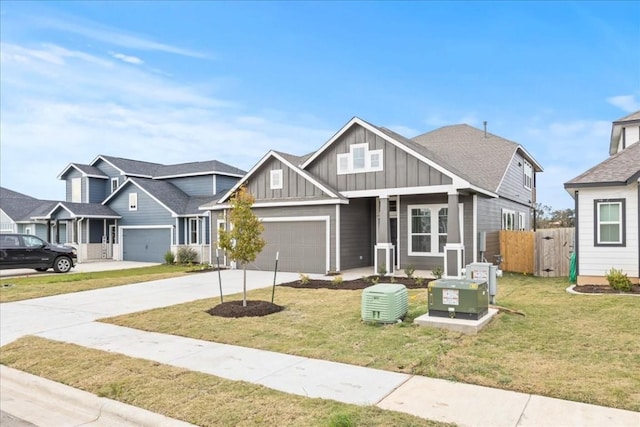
[362, 283, 409, 323]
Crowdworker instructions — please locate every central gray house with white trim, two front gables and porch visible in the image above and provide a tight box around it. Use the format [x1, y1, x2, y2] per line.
[202, 117, 542, 277]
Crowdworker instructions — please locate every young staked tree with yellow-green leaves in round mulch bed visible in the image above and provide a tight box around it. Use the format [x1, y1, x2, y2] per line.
[219, 186, 266, 307]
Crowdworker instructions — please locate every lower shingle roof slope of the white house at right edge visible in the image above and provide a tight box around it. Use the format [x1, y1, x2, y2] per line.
[564, 142, 640, 188]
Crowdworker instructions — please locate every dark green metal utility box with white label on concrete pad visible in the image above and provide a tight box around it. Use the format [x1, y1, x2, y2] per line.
[429, 279, 489, 320]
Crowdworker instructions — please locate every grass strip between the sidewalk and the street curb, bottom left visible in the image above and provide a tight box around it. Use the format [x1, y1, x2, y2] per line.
[0, 337, 447, 427]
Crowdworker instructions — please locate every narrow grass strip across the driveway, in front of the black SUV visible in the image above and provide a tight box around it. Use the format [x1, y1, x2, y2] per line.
[0, 264, 188, 302]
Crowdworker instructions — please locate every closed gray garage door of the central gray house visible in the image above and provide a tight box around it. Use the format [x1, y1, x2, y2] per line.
[249, 219, 328, 274]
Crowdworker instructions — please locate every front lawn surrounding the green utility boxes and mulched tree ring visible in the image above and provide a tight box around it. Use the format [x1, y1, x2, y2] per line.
[104, 275, 640, 411]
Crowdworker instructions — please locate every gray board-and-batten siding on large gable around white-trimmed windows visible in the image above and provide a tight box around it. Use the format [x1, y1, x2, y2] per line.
[307, 125, 452, 191]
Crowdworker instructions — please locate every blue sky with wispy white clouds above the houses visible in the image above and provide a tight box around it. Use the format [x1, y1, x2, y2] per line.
[0, 1, 640, 209]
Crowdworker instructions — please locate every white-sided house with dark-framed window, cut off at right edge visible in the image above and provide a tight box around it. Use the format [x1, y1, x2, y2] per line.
[564, 111, 640, 285]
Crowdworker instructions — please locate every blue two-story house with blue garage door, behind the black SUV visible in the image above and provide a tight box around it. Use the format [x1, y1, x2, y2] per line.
[2, 155, 245, 262]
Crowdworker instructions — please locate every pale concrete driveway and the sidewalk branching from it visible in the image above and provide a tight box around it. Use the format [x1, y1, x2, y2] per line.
[0, 270, 640, 427]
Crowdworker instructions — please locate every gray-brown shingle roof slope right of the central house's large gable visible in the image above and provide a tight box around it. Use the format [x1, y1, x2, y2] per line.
[413, 124, 539, 191]
